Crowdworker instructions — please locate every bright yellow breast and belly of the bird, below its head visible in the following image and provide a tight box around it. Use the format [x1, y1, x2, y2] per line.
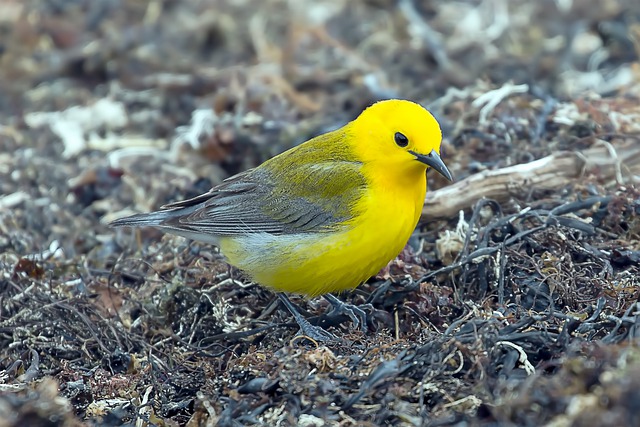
[220, 162, 426, 296]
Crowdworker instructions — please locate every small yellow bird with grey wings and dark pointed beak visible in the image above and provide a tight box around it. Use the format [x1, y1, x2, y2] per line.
[111, 100, 452, 340]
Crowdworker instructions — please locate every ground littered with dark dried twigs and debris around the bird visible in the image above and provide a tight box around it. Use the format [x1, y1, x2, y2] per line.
[0, 0, 640, 426]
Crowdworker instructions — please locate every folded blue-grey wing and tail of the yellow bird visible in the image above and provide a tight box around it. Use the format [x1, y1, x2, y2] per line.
[113, 163, 366, 237]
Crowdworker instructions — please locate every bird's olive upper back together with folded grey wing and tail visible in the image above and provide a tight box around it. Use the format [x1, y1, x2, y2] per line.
[112, 130, 368, 241]
